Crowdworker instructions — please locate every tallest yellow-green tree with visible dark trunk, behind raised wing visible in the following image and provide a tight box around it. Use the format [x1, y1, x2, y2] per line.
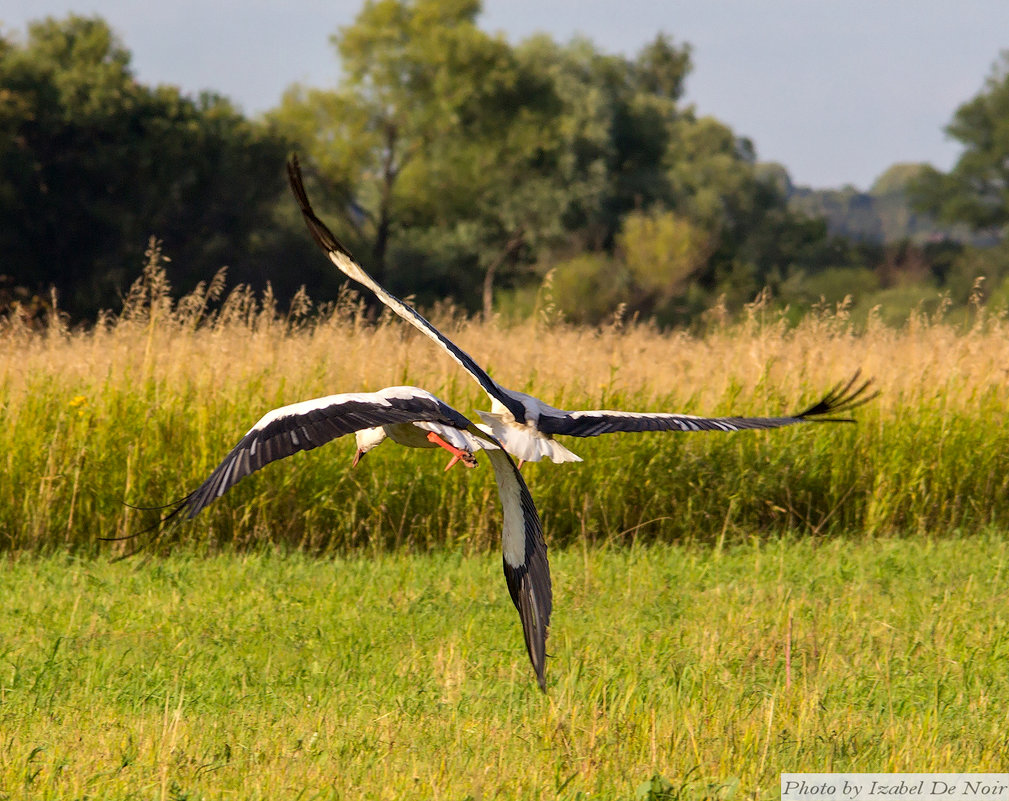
[274, 0, 517, 280]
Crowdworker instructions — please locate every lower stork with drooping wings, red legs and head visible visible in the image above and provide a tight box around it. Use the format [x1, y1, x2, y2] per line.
[147, 386, 552, 691]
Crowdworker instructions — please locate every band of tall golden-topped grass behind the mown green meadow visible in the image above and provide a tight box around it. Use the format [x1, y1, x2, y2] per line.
[0, 246, 1009, 551]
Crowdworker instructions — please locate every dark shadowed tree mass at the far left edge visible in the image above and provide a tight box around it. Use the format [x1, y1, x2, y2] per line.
[0, 16, 287, 315]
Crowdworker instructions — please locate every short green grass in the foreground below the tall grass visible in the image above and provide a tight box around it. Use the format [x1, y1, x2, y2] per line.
[0, 534, 1009, 799]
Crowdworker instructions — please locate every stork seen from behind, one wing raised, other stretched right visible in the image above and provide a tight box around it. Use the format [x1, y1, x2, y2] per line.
[288, 155, 877, 467]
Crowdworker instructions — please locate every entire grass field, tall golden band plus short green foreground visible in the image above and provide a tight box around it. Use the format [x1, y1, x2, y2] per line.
[0, 253, 1009, 801]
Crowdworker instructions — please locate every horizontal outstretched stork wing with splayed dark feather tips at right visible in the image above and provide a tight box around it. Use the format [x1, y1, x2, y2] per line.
[539, 371, 879, 437]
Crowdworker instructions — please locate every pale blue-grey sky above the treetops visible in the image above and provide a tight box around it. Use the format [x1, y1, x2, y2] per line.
[0, 0, 1009, 189]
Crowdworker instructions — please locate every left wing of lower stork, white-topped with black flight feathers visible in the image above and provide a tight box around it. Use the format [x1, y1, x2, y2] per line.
[176, 386, 471, 518]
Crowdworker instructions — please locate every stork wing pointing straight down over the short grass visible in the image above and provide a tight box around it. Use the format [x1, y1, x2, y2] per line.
[485, 449, 553, 692]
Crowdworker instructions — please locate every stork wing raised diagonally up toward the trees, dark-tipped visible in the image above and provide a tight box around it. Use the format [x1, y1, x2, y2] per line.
[288, 155, 526, 421]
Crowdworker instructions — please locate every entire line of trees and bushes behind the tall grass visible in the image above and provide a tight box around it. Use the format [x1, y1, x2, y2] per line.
[0, 0, 1009, 325]
